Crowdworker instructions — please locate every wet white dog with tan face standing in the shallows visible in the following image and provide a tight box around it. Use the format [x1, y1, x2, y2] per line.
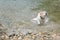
[31, 11, 48, 24]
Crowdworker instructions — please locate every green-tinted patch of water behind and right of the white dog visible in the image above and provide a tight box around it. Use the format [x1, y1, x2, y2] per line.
[33, 0, 60, 22]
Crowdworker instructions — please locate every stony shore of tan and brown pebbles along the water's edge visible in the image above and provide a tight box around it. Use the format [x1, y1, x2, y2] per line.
[0, 24, 60, 40]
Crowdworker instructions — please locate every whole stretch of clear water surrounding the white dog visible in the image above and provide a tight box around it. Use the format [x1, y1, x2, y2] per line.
[0, 0, 60, 34]
